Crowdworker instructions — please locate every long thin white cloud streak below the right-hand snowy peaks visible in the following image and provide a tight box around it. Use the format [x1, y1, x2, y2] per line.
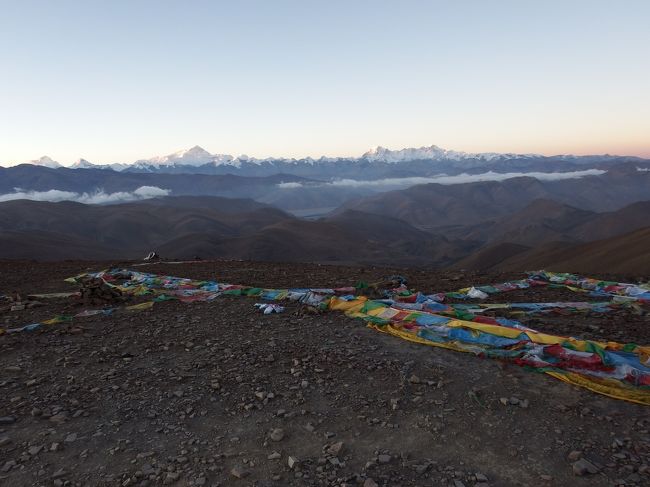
[278, 169, 606, 189]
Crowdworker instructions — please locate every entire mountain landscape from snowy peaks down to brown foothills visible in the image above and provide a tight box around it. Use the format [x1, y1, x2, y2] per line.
[0, 146, 650, 273]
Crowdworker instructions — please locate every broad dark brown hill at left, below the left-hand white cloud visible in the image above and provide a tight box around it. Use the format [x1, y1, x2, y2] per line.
[0, 197, 293, 260]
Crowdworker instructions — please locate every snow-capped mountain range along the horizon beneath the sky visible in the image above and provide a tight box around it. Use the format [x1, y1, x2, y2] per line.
[13, 145, 650, 180]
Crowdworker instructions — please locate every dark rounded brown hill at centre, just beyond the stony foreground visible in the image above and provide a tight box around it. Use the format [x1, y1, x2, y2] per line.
[160, 212, 468, 265]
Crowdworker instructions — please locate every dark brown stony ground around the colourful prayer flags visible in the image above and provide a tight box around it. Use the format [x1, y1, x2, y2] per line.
[0, 261, 650, 487]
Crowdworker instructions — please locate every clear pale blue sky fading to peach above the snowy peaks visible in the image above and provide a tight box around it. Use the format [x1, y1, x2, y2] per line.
[0, 0, 650, 165]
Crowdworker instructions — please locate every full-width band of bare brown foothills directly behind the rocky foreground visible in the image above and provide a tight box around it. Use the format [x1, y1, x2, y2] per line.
[0, 193, 650, 274]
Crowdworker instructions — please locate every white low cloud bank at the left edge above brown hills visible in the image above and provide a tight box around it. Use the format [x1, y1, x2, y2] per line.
[0, 186, 170, 205]
